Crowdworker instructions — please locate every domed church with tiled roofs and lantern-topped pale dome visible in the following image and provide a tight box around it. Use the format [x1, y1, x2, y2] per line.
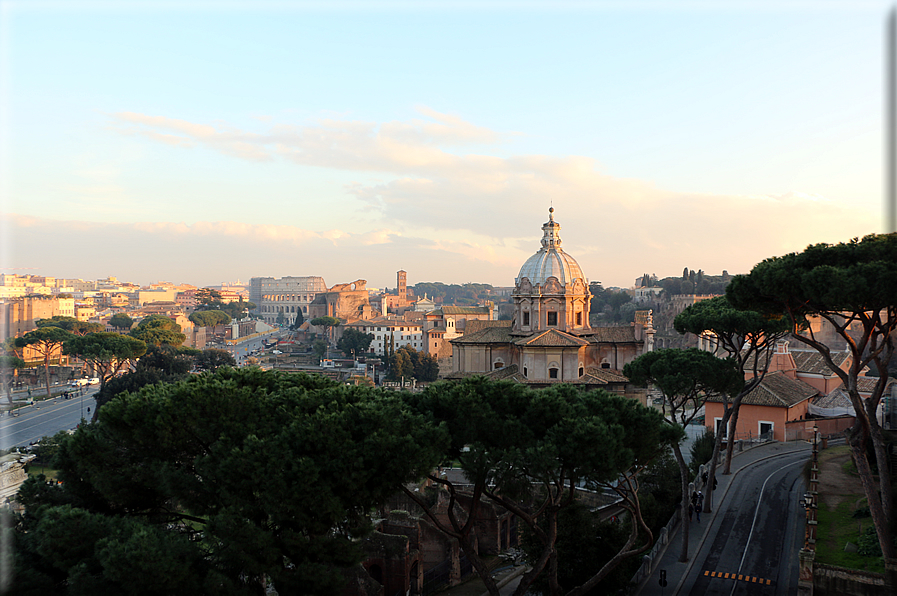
[450, 208, 654, 393]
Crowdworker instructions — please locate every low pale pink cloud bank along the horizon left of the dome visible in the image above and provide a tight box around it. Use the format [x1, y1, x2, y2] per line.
[2, 214, 520, 286]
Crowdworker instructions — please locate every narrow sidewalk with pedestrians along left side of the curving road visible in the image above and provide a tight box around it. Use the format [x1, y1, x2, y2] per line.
[633, 441, 808, 596]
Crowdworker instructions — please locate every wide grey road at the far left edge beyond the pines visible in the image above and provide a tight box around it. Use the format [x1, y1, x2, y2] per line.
[0, 387, 97, 449]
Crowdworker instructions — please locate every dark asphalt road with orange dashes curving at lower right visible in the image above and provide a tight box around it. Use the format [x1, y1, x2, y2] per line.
[679, 451, 809, 596]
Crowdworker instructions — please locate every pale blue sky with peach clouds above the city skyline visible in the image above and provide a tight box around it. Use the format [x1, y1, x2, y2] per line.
[0, 0, 893, 287]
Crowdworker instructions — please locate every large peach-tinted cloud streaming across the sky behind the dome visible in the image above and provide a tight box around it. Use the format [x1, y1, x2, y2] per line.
[98, 112, 878, 285]
